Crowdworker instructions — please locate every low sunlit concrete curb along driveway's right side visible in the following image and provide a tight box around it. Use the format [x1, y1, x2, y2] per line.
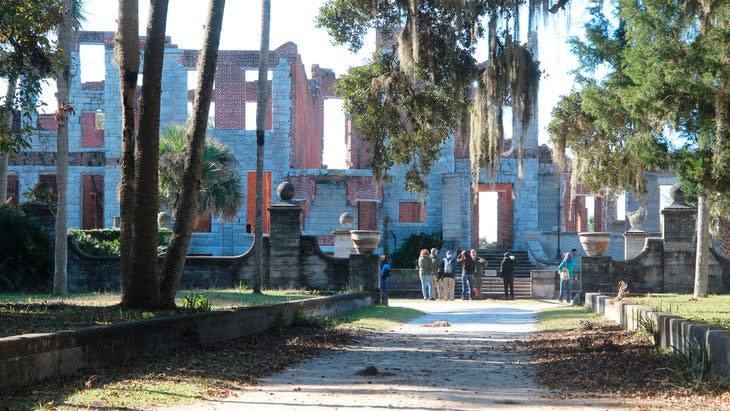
[585, 293, 730, 378]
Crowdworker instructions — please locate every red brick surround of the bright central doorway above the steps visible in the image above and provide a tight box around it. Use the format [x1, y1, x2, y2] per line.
[471, 183, 514, 248]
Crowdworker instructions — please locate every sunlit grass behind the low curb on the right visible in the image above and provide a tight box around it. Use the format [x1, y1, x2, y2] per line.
[624, 294, 730, 329]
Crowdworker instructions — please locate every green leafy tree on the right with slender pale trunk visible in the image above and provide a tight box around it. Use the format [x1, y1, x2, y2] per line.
[552, 0, 730, 297]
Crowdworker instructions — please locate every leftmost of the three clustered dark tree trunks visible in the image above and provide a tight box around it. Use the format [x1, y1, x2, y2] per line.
[115, 0, 139, 306]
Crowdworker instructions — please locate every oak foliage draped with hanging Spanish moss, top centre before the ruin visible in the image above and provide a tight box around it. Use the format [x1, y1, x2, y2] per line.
[317, 0, 556, 191]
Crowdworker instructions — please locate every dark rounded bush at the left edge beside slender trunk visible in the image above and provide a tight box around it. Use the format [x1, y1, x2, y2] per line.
[0, 206, 53, 292]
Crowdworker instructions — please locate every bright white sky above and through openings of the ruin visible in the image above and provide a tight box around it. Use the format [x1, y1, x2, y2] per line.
[31, 0, 586, 168]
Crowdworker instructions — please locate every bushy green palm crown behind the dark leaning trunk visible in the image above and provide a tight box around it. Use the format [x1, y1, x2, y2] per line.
[159, 124, 243, 219]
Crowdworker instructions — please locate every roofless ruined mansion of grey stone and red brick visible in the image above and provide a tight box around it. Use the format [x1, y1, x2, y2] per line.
[8, 32, 675, 261]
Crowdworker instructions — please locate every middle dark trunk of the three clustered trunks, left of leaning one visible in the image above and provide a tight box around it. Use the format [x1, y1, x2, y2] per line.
[127, 0, 168, 308]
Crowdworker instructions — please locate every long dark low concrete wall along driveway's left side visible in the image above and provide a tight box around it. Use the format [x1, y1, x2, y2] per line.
[0, 293, 371, 391]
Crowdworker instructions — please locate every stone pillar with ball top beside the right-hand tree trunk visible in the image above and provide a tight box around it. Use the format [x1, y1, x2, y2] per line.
[661, 188, 697, 293]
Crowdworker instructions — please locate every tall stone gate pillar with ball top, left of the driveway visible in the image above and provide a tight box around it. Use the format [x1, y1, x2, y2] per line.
[268, 182, 302, 288]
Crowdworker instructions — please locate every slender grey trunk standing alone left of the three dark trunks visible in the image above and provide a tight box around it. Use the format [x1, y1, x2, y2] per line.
[53, 0, 74, 295]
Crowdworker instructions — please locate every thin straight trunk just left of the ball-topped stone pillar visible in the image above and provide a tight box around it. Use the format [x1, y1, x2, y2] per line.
[253, 0, 271, 293]
